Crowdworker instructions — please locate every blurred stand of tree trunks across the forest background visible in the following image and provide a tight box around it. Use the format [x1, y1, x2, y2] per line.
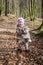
[0, 0, 42, 20]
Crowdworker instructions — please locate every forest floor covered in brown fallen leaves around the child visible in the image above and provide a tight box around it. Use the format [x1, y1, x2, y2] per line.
[0, 16, 43, 65]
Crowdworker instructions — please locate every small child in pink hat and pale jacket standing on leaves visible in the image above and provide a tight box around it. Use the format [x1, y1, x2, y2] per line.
[16, 17, 31, 52]
